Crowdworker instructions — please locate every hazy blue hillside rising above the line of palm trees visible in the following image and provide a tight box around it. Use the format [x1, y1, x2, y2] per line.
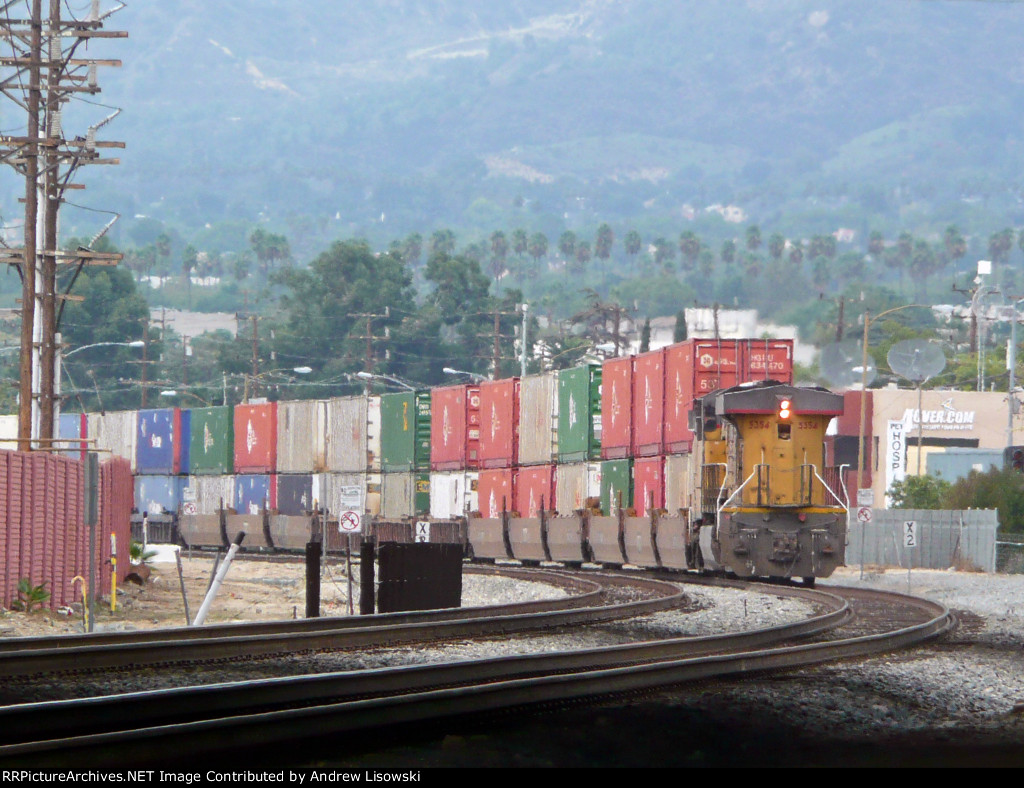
[24, 0, 1024, 248]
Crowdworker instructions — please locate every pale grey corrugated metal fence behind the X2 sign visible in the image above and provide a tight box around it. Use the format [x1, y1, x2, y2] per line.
[846, 509, 998, 572]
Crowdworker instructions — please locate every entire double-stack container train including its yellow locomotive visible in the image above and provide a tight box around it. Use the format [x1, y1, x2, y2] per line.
[72, 339, 847, 578]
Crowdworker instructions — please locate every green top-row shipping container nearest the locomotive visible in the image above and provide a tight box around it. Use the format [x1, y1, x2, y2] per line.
[558, 364, 601, 463]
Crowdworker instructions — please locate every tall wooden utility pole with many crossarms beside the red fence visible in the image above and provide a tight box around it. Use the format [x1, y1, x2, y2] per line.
[0, 0, 127, 450]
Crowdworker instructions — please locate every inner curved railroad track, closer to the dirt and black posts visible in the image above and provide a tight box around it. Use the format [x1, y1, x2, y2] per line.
[0, 567, 683, 678]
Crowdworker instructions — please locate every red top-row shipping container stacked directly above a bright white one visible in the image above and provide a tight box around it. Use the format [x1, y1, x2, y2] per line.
[430, 386, 480, 471]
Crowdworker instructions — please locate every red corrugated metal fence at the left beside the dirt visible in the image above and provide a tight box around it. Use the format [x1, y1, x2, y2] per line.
[0, 451, 134, 609]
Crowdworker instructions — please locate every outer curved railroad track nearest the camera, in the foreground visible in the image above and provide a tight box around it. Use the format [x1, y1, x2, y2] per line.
[0, 578, 952, 767]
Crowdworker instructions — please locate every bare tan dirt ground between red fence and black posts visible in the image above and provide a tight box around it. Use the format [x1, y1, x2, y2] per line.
[0, 551, 358, 638]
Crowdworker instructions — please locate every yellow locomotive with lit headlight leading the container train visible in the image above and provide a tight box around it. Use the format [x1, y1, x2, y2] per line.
[690, 381, 849, 584]
